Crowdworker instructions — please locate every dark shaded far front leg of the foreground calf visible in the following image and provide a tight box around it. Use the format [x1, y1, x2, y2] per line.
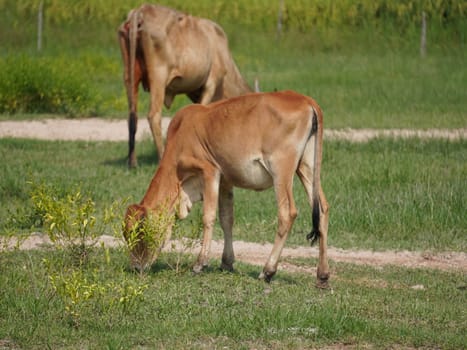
[219, 182, 235, 271]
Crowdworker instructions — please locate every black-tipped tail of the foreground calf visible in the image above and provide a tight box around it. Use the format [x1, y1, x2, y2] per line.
[306, 107, 323, 245]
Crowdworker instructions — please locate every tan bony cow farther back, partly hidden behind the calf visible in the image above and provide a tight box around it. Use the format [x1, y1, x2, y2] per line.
[118, 4, 251, 167]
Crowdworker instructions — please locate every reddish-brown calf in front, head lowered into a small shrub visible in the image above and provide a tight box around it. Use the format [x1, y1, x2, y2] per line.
[125, 91, 329, 286]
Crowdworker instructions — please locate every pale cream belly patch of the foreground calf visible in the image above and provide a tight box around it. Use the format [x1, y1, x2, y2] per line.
[223, 158, 273, 191]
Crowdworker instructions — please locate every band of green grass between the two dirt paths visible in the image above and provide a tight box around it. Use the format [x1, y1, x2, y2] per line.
[0, 135, 467, 251]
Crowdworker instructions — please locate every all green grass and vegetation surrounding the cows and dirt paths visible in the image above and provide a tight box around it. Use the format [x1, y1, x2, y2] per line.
[0, 0, 467, 349]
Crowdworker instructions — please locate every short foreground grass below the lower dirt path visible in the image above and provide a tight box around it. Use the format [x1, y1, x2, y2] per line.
[0, 250, 467, 349]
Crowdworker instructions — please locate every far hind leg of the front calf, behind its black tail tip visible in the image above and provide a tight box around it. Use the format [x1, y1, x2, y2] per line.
[297, 160, 329, 288]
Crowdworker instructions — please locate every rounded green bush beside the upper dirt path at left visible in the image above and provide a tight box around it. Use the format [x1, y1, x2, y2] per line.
[0, 55, 97, 116]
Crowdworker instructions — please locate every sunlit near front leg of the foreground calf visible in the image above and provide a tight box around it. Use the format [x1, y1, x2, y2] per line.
[193, 166, 220, 273]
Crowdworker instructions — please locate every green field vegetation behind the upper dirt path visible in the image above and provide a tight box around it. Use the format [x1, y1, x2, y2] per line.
[0, 0, 467, 128]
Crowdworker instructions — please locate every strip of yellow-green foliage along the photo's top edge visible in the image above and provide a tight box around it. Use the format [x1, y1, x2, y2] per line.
[0, 0, 467, 30]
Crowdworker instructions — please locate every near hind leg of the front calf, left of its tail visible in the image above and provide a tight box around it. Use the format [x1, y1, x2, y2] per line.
[259, 171, 297, 282]
